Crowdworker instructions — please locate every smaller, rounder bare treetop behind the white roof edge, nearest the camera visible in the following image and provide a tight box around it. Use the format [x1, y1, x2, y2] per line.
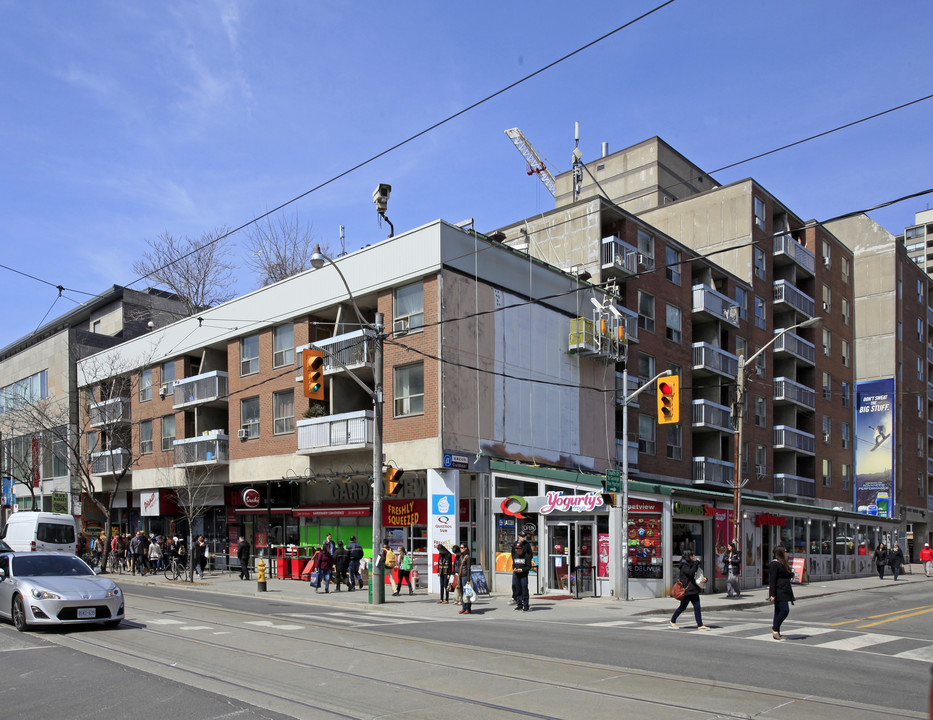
[246, 212, 327, 286]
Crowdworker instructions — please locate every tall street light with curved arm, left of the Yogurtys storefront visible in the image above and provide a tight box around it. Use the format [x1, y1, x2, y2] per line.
[311, 245, 385, 605]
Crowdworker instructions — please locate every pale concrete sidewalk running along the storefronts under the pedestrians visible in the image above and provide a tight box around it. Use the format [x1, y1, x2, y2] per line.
[107, 571, 933, 622]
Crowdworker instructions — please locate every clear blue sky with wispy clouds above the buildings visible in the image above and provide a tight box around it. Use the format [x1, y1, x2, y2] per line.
[0, 0, 933, 347]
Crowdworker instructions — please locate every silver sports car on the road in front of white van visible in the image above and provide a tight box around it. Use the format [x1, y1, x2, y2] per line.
[0, 553, 123, 632]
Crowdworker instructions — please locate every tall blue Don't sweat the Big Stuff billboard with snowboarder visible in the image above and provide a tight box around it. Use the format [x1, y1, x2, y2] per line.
[854, 378, 895, 517]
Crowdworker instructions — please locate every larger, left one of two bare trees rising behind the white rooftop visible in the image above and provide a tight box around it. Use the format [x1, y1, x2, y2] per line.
[133, 227, 236, 315]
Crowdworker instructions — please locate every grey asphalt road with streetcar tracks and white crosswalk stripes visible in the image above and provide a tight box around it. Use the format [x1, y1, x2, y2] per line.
[0, 582, 933, 720]
